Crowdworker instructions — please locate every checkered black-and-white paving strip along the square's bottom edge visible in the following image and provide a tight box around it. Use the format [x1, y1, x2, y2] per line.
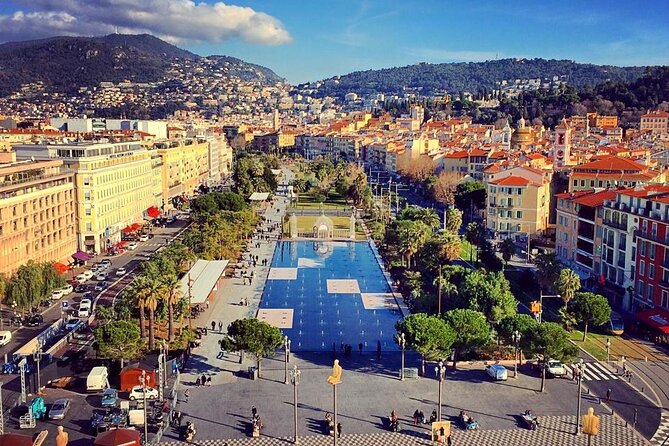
[161, 415, 647, 446]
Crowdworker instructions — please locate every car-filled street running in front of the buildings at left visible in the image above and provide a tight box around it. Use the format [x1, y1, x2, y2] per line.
[0, 220, 188, 362]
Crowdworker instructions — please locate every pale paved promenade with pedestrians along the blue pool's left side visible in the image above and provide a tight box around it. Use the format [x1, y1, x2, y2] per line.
[179, 196, 286, 390]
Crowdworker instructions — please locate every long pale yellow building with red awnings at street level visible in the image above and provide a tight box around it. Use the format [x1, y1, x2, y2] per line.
[15, 141, 162, 253]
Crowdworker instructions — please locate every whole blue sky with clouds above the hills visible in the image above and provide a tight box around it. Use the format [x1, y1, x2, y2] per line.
[0, 0, 669, 84]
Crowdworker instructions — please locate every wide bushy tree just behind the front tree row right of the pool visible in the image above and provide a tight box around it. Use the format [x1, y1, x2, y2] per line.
[457, 269, 518, 324]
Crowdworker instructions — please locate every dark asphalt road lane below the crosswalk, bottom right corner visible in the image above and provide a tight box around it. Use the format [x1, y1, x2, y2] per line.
[583, 379, 662, 439]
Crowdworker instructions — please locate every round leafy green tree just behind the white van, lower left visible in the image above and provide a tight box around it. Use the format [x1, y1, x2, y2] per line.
[93, 320, 143, 368]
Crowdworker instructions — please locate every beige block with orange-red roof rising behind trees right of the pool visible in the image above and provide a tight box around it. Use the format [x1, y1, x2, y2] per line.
[486, 167, 550, 238]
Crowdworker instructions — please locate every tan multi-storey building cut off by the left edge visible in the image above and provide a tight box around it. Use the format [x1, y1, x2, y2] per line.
[0, 151, 77, 275]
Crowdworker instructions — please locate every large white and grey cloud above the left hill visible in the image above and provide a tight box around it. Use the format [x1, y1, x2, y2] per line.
[0, 0, 292, 45]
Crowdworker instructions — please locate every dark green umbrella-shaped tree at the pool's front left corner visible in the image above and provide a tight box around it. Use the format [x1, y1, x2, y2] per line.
[228, 319, 283, 376]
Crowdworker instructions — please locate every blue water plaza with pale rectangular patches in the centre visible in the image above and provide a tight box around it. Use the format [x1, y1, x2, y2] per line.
[258, 241, 401, 351]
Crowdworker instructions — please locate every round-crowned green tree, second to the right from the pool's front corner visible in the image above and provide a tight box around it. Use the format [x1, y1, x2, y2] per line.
[444, 308, 491, 368]
